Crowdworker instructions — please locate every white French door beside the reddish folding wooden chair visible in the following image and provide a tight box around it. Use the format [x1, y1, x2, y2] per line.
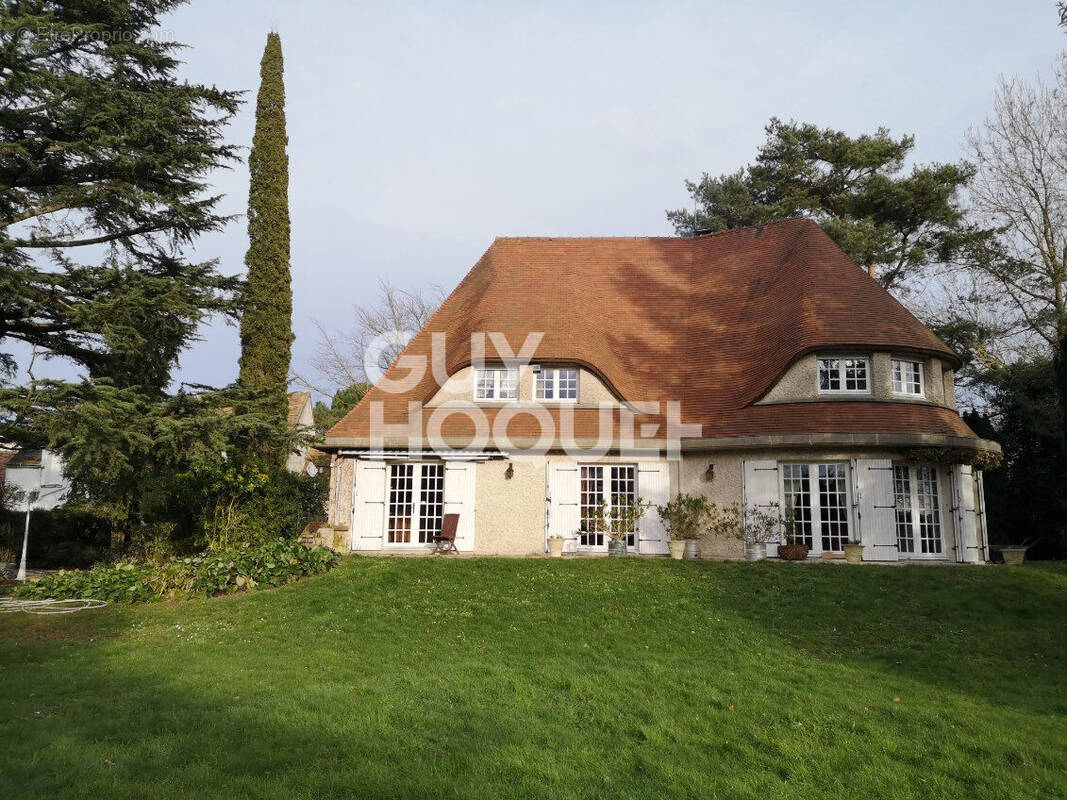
[385, 463, 445, 545]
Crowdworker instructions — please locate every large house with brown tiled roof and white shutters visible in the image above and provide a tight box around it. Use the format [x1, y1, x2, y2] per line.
[323, 220, 1000, 562]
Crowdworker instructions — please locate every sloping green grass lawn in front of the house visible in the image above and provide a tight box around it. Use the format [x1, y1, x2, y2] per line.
[0, 558, 1067, 800]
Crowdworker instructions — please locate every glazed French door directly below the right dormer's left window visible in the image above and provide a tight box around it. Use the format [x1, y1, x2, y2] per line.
[782, 464, 849, 554]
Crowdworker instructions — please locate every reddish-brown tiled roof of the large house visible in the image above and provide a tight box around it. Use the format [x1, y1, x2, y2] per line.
[327, 220, 974, 446]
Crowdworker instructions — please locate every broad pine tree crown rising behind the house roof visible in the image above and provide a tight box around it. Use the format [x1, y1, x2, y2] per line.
[667, 118, 981, 288]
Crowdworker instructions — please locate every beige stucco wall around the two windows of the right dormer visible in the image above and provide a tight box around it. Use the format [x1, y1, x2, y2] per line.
[760, 351, 955, 407]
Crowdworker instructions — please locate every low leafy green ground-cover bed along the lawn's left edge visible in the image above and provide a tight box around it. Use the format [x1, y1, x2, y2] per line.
[15, 540, 339, 603]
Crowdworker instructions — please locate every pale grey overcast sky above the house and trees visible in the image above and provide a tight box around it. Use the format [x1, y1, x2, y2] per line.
[154, 0, 1067, 401]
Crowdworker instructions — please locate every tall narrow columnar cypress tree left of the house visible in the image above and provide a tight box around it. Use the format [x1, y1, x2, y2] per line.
[240, 33, 292, 459]
